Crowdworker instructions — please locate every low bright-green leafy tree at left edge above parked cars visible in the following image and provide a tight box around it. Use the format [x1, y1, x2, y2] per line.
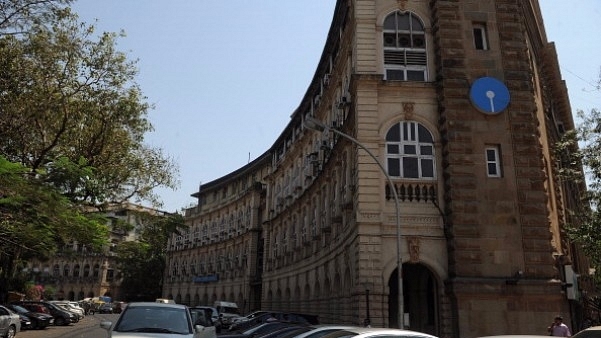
[0, 156, 108, 298]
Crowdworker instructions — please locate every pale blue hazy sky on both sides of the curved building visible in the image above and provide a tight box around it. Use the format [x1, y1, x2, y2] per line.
[73, 0, 601, 211]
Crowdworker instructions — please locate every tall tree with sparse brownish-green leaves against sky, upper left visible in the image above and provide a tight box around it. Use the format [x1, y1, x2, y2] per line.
[0, 7, 177, 206]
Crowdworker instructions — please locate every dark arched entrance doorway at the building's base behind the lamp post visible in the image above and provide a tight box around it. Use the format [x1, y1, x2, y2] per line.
[388, 264, 439, 335]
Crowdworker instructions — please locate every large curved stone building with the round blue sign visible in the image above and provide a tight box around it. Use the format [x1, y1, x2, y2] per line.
[164, 0, 591, 338]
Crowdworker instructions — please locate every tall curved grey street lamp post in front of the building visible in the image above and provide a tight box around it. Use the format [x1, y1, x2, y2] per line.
[304, 117, 405, 329]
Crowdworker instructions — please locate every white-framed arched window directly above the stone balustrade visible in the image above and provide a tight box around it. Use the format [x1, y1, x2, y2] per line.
[386, 121, 435, 179]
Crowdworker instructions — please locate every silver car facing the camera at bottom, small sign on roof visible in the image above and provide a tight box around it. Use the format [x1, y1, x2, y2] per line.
[100, 302, 217, 338]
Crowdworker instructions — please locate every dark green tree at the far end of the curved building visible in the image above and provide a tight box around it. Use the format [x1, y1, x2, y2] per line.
[116, 213, 186, 301]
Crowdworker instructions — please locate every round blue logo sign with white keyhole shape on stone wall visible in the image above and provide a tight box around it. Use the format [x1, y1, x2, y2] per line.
[470, 77, 510, 115]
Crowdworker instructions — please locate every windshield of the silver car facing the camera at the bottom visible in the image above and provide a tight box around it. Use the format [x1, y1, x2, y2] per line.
[113, 306, 192, 334]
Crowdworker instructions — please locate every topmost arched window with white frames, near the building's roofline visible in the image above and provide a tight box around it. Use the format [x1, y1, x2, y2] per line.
[383, 11, 428, 81]
